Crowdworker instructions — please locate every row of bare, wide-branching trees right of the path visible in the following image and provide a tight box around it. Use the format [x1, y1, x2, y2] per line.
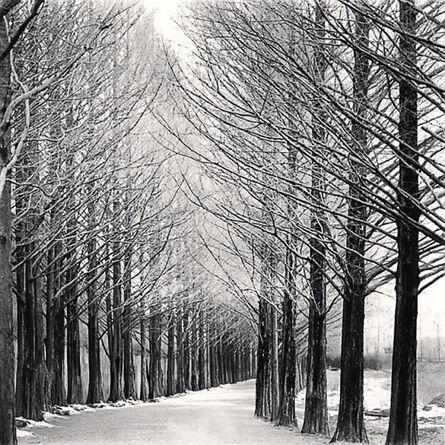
[166, 0, 445, 445]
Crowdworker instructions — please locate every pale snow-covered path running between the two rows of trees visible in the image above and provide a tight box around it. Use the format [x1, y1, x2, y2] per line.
[19, 380, 326, 445]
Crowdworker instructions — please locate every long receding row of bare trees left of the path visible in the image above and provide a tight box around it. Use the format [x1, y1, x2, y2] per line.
[0, 0, 256, 445]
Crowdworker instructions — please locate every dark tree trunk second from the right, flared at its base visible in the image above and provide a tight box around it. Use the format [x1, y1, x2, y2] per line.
[331, 8, 369, 443]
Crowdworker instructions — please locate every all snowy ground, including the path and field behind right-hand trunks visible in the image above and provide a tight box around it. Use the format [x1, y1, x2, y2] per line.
[19, 371, 445, 445]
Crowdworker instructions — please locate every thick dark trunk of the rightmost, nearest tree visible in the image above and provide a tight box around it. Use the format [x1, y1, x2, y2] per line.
[386, 0, 420, 445]
